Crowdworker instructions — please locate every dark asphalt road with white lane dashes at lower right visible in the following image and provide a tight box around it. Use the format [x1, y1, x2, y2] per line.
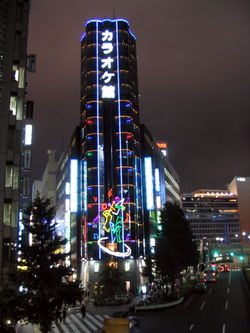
[141, 271, 250, 333]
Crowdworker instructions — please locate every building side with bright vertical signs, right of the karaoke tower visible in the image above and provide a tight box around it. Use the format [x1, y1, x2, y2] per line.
[141, 124, 180, 256]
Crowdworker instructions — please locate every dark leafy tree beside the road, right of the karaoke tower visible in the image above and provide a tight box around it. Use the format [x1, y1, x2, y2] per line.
[155, 202, 199, 287]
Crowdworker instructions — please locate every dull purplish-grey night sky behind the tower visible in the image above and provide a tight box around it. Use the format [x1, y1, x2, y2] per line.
[28, 0, 250, 192]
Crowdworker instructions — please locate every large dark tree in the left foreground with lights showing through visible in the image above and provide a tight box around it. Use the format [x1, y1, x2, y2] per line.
[0, 196, 81, 333]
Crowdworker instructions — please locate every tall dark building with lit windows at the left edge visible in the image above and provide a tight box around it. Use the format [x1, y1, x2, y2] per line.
[0, 0, 33, 286]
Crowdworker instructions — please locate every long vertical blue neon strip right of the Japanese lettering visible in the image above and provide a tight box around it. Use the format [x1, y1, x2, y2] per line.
[115, 20, 125, 252]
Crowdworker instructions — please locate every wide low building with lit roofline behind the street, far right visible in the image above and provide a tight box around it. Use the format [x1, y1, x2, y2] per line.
[182, 190, 240, 252]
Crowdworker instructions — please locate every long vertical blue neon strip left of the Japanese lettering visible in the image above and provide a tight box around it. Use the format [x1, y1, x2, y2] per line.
[96, 21, 102, 259]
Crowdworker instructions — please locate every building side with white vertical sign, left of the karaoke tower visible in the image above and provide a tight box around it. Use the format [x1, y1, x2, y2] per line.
[56, 126, 82, 272]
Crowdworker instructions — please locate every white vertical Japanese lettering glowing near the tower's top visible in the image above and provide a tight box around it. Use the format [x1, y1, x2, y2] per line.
[99, 29, 115, 98]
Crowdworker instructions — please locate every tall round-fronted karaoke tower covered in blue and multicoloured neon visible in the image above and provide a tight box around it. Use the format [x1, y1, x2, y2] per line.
[81, 19, 144, 290]
